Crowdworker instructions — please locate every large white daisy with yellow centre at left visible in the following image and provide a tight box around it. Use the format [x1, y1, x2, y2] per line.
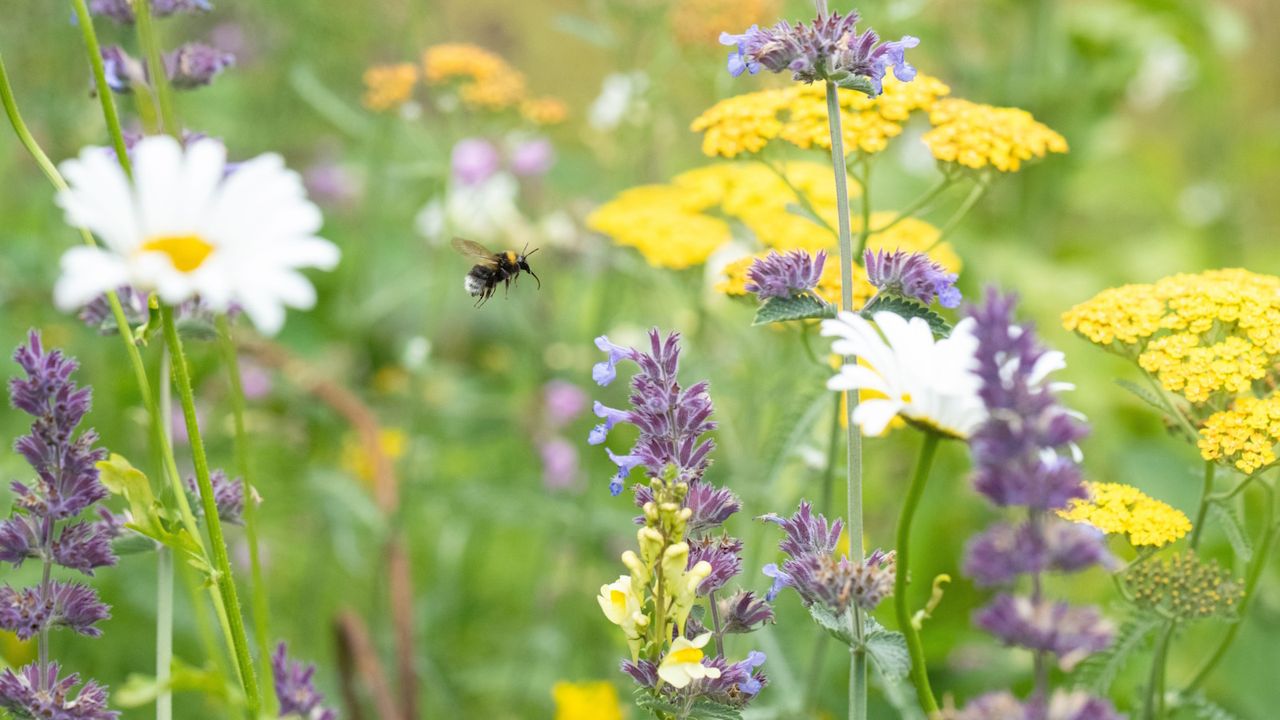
[54, 136, 338, 334]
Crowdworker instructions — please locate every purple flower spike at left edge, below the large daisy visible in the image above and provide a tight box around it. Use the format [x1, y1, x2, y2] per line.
[0, 332, 118, 720]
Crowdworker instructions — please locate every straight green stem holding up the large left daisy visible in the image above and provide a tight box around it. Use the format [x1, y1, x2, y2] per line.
[218, 315, 274, 711]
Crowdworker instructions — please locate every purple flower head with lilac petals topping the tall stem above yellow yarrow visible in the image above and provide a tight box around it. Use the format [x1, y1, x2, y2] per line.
[721, 10, 920, 96]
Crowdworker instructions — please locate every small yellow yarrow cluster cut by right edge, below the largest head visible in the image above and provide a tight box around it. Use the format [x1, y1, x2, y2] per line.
[1198, 395, 1280, 475]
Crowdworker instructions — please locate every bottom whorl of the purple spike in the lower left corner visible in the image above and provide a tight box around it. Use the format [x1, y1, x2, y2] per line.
[0, 662, 120, 720]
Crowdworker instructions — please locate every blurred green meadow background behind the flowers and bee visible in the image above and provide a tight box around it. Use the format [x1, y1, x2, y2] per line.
[0, 0, 1280, 719]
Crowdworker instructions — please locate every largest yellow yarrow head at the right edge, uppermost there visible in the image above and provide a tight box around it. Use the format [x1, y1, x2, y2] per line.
[1062, 269, 1280, 407]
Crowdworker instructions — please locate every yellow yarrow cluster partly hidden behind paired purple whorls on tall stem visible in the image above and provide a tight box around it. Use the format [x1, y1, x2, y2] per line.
[716, 211, 961, 306]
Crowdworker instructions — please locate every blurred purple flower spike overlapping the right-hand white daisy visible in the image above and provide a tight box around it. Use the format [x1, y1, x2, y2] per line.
[955, 292, 1119, 720]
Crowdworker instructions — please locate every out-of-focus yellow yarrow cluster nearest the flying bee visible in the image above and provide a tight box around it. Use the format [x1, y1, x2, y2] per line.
[586, 163, 836, 269]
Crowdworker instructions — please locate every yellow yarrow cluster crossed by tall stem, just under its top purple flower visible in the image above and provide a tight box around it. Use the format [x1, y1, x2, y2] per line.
[690, 74, 951, 158]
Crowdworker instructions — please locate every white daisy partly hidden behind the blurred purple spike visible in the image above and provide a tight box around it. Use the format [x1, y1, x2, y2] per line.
[822, 313, 987, 438]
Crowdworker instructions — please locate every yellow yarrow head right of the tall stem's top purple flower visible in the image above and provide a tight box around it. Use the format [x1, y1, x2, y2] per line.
[923, 99, 1068, 173]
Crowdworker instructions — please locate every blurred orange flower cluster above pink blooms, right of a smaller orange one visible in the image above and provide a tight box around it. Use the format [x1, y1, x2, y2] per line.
[422, 42, 568, 124]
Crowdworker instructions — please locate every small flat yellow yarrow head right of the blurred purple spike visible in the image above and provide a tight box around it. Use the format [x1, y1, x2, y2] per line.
[1059, 483, 1192, 547]
